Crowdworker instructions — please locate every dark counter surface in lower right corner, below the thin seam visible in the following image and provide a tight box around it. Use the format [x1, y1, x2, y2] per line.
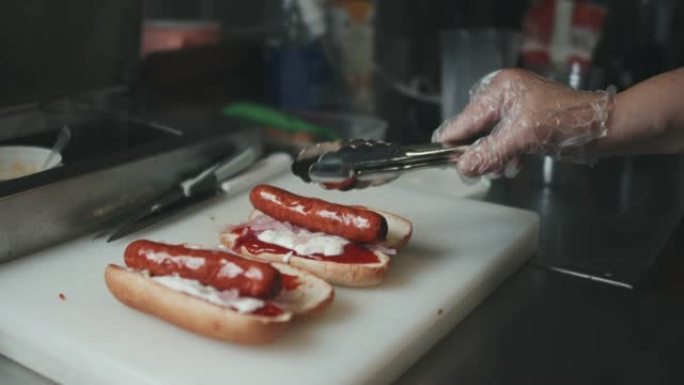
[397, 260, 684, 385]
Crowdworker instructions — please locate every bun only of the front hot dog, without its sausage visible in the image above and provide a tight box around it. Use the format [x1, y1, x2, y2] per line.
[105, 264, 334, 345]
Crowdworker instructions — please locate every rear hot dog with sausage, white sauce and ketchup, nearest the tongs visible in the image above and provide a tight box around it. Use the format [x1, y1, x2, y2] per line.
[221, 185, 412, 286]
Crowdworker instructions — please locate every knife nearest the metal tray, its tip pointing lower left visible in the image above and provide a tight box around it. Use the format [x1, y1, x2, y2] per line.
[107, 148, 256, 242]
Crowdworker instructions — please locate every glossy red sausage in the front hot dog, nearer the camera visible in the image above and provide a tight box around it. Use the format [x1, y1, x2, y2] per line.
[124, 240, 282, 299]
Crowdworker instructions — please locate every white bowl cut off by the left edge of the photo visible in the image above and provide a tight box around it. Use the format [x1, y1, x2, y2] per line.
[0, 146, 62, 180]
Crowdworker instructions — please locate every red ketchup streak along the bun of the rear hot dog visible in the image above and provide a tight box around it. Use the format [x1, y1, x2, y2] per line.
[231, 226, 380, 263]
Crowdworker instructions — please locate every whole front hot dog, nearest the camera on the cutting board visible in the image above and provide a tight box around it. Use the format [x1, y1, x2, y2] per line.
[105, 240, 334, 344]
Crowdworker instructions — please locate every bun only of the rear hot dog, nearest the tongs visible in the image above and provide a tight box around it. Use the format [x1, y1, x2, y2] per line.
[220, 208, 413, 287]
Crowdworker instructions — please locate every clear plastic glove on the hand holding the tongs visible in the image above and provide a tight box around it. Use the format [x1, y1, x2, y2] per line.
[432, 69, 615, 178]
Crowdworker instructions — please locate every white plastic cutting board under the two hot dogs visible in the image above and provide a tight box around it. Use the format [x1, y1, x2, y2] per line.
[0, 176, 538, 385]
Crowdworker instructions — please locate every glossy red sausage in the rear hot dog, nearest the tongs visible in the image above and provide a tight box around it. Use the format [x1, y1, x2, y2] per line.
[249, 185, 387, 243]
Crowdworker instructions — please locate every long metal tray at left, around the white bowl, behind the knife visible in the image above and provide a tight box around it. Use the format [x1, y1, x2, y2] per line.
[0, 111, 262, 261]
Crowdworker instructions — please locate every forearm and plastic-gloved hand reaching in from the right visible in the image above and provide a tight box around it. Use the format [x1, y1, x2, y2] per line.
[433, 69, 684, 177]
